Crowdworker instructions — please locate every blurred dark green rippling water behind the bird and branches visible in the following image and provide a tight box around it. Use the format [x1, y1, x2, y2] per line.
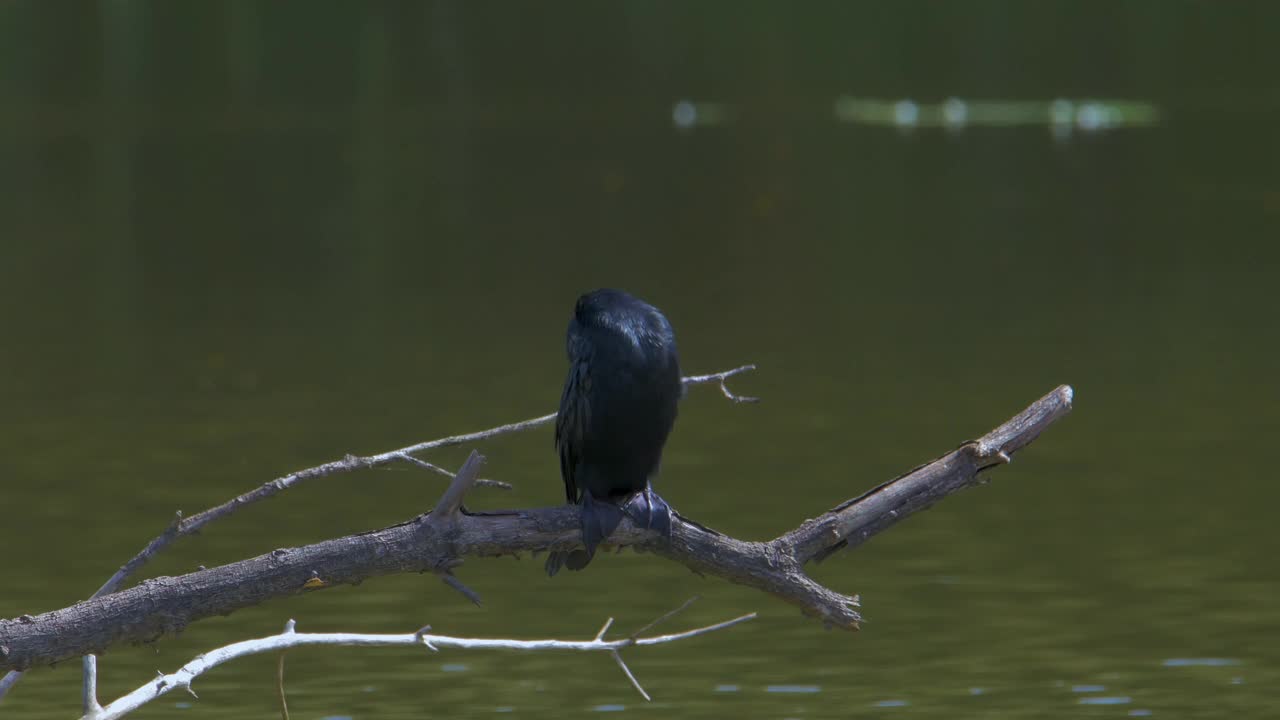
[0, 0, 1280, 719]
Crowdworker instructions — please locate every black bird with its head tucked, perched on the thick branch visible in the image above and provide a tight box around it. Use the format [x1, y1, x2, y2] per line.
[547, 290, 684, 575]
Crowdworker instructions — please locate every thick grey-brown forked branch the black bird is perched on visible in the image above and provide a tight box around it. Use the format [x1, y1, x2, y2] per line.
[0, 386, 1073, 670]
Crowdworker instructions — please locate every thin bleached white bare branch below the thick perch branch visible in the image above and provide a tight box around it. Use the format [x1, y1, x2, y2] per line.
[81, 603, 755, 720]
